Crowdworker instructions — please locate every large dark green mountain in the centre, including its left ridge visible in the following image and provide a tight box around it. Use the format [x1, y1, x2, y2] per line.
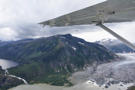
[0, 34, 117, 85]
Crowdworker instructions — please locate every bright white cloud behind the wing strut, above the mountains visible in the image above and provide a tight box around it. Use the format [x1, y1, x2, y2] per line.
[73, 22, 135, 42]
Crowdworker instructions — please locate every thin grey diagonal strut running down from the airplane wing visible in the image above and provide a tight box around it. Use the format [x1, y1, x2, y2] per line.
[97, 23, 135, 50]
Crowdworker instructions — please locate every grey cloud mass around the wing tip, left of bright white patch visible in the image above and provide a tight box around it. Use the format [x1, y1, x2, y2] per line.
[0, 0, 103, 41]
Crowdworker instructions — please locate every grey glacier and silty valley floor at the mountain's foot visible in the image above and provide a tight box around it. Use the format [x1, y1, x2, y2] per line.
[10, 53, 135, 90]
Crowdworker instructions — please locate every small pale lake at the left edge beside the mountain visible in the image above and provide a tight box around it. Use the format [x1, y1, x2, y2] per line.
[0, 59, 18, 69]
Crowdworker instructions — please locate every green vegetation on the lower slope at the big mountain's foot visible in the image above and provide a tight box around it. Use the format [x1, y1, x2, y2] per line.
[9, 62, 72, 86]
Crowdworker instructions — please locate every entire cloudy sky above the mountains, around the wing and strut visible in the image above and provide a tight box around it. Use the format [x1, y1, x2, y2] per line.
[0, 0, 135, 42]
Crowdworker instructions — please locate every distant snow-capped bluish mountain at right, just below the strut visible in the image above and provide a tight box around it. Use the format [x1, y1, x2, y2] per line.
[96, 39, 135, 53]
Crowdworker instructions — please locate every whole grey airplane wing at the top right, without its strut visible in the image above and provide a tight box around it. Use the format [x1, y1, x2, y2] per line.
[39, 0, 135, 27]
